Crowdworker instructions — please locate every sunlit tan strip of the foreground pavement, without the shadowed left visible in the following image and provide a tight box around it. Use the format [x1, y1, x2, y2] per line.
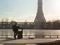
[3, 39, 60, 45]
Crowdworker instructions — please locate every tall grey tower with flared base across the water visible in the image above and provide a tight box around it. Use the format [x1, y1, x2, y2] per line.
[34, 0, 46, 28]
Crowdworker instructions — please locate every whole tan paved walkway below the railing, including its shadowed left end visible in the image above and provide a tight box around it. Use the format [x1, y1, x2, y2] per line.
[0, 38, 60, 45]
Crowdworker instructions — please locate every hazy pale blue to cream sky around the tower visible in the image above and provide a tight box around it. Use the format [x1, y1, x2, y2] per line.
[0, 0, 60, 22]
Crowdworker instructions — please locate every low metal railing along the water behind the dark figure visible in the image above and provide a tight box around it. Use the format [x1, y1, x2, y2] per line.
[0, 35, 60, 39]
